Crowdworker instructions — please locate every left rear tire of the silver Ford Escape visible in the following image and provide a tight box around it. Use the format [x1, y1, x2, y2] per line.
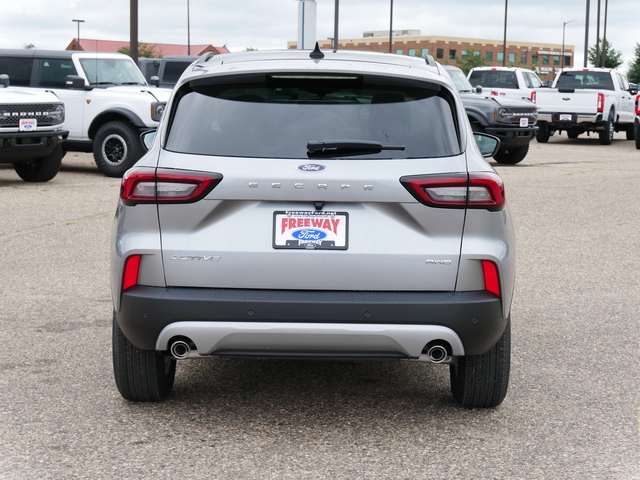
[112, 313, 176, 402]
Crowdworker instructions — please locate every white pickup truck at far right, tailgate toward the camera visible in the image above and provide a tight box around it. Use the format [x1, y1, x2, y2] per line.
[531, 68, 638, 145]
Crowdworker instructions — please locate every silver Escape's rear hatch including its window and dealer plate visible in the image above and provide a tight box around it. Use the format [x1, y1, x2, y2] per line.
[158, 72, 466, 291]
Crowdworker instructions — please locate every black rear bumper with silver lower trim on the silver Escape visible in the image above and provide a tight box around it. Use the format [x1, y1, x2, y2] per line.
[116, 286, 507, 357]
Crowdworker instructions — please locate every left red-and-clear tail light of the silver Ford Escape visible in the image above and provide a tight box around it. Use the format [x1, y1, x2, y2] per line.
[120, 168, 222, 206]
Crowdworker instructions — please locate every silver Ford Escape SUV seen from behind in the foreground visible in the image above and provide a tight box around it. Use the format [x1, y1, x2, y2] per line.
[111, 48, 515, 407]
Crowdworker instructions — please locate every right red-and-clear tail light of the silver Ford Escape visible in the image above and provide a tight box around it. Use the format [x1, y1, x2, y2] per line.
[400, 172, 505, 211]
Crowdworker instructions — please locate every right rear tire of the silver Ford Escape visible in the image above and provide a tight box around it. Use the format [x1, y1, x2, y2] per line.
[449, 320, 511, 408]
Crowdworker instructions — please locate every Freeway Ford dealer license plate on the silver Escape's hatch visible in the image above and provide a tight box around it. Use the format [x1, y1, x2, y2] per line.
[273, 211, 349, 250]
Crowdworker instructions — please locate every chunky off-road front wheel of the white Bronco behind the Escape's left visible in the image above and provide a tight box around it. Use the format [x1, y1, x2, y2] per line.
[93, 121, 144, 177]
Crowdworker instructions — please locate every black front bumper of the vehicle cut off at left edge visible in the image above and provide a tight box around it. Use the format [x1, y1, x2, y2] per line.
[0, 130, 69, 163]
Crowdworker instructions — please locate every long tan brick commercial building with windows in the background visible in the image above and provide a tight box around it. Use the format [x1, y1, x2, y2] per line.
[287, 30, 575, 80]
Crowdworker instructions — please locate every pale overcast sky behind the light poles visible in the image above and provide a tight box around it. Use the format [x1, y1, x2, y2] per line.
[0, 0, 640, 68]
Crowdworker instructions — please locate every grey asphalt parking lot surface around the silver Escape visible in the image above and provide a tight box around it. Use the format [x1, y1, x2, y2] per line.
[0, 134, 640, 480]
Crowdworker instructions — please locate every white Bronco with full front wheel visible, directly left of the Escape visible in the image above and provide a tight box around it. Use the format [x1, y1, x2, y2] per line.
[0, 50, 171, 177]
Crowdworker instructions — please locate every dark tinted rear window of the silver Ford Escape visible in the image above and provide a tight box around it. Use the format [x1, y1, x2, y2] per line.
[166, 73, 460, 158]
